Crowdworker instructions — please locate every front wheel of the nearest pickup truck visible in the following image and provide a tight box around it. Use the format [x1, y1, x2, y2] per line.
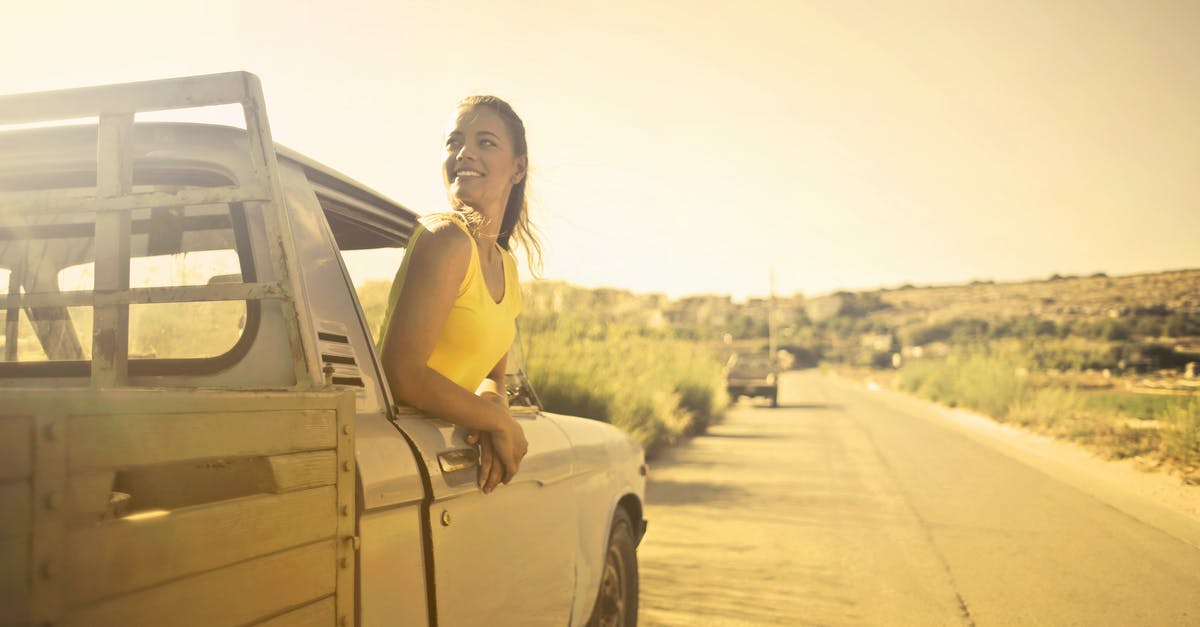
[588, 507, 637, 627]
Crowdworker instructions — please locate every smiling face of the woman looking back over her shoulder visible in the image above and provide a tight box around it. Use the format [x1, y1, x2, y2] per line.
[442, 107, 526, 217]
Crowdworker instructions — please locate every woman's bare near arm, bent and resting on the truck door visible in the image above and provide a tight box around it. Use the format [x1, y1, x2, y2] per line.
[380, 225, 527, 480]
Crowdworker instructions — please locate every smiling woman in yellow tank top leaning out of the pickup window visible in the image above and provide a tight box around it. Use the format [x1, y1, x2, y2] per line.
[379, 96, 540, 492]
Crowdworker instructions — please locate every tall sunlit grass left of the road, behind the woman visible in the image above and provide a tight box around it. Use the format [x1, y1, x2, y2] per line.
[358, 281, 728, 454]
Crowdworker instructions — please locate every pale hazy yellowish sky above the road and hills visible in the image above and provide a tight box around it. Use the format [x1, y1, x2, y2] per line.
[0, 0, 1200, 298]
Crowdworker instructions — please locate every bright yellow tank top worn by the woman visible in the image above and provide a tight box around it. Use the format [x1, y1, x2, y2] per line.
[377, 214, 522, 392]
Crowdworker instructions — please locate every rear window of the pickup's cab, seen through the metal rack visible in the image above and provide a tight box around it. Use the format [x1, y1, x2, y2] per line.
[0, 192, 258, 376]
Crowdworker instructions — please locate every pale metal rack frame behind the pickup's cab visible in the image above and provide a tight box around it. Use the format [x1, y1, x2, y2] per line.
[0, 72, 322, 388]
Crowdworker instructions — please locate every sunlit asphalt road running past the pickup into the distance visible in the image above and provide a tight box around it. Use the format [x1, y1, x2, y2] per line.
[638, 371, 1200, 626]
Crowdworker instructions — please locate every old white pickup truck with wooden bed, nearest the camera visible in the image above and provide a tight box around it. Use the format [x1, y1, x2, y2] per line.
[0, 72, 647, 626]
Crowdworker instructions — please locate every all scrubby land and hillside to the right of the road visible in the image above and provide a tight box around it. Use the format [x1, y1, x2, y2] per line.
[792, 270, 1200, 484]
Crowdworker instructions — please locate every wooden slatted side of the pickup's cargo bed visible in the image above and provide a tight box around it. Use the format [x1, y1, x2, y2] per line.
[0, 389, 356, 626]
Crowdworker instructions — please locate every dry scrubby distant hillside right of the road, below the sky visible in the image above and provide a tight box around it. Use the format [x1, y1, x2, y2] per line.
[797, 269, 1200, 372]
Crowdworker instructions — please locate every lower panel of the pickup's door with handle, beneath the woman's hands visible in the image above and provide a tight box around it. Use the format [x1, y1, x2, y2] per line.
[397, 393, 577, 626]
